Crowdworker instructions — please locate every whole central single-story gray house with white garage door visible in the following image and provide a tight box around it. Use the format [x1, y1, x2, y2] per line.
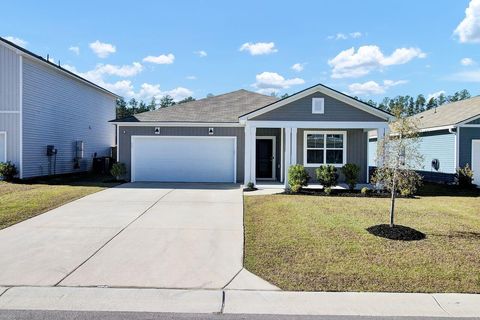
[112, 85, 391, 183]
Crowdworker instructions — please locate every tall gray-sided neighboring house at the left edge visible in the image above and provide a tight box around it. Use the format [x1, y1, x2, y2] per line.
[0, 38, 117, 178]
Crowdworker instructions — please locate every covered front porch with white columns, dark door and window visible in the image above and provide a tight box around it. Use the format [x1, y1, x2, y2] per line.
[244, 120, 388, 189]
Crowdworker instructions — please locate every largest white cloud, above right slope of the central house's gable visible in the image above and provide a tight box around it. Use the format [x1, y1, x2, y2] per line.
[328, 45, 426, 79]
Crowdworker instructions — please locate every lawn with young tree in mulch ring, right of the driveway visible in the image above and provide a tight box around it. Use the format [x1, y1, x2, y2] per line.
[245, 185, 480, 293]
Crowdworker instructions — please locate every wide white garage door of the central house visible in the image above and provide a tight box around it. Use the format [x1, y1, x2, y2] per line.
[132, 136, 236, 182]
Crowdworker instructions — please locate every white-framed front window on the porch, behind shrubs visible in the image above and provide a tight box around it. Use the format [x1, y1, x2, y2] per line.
[304, 131, 346, 167]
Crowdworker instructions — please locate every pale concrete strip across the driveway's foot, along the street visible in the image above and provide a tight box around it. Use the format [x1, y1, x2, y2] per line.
[0, 287, 480, 317]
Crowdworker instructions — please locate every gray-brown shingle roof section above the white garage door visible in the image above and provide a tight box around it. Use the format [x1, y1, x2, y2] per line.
[115, 89, 278, 123]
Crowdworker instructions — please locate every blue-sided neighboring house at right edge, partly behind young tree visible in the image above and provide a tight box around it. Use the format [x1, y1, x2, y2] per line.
[369, 96, 480, 184]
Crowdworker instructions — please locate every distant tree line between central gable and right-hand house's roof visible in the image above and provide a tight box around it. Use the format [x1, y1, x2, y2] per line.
[355, 89, 471, 116]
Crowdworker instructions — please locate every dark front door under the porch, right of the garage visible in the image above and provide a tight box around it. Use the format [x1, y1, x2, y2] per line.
[255, 137, 275, 179]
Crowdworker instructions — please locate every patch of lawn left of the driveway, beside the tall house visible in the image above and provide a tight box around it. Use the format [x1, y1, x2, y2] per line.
[0, 175, 118, 229]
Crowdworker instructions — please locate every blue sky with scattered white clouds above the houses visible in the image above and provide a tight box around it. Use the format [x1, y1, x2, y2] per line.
[0, 0, 480, 100]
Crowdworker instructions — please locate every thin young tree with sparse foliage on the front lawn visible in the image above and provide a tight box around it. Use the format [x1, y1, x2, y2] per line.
[372, 110, 423, 227]
